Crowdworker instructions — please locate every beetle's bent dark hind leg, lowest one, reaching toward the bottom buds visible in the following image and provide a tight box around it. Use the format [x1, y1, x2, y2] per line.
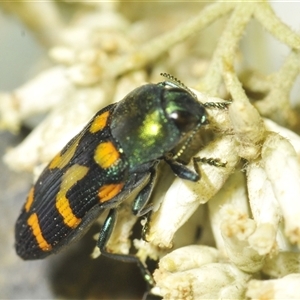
[97, 208, 154, 288]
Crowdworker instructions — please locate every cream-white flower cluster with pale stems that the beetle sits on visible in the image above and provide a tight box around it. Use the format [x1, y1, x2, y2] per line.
[0, 1, 300, 300]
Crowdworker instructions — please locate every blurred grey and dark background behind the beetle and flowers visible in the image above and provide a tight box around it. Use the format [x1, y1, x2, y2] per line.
[0, 1, 300, 299]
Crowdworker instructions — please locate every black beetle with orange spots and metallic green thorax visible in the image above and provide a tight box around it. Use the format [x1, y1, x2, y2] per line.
[15, 74, 227, 284]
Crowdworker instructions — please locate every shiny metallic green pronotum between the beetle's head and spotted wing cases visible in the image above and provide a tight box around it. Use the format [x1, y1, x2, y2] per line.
[110, 84, 181, 168]
